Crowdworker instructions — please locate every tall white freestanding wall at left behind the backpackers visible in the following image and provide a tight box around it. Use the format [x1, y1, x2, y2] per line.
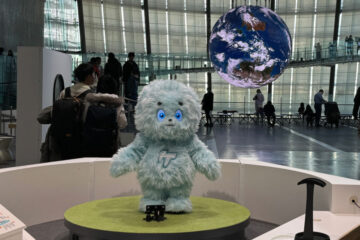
[16, 47, 71, 165]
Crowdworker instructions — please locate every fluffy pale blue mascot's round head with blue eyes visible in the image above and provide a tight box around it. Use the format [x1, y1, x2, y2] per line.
[135, 80, 201, 140]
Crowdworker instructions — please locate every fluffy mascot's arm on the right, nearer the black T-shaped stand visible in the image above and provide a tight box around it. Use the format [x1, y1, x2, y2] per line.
[189, 136, 221, 180]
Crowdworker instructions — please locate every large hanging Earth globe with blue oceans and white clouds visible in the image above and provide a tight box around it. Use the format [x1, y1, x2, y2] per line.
[209, 6, 291, 88]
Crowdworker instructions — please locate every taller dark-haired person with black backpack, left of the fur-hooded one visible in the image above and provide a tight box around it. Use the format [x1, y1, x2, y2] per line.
[51, 63, 96, 160]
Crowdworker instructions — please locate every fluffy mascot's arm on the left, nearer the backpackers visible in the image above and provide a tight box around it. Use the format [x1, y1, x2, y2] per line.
[110, 134, 147, 177]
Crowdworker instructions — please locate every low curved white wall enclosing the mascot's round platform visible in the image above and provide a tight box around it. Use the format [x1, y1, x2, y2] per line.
[0, 158, 360, 239]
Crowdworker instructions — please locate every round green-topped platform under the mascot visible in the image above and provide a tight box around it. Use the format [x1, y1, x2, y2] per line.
[64, 196, 250, 240]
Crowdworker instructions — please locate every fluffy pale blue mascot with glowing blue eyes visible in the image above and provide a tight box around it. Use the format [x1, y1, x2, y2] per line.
[110, 80, 221, 212]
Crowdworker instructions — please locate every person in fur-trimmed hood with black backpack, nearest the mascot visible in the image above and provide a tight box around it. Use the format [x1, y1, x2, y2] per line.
[82, 75, 127, 157]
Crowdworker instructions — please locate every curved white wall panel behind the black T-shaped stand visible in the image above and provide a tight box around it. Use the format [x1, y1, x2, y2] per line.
[240, 161, 332, 224]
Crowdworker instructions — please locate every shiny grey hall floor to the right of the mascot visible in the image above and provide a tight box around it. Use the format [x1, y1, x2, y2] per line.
[198, 120, 360, 180]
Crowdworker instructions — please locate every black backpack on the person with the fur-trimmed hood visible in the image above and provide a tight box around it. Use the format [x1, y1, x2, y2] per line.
[82, 103, 118, 157]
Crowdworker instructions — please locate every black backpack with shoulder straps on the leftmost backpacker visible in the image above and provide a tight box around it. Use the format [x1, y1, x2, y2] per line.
[51, 87, 91, 160]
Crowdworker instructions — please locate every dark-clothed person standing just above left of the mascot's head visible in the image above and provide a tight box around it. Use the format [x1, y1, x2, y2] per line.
[123, 52, 140, 101]
